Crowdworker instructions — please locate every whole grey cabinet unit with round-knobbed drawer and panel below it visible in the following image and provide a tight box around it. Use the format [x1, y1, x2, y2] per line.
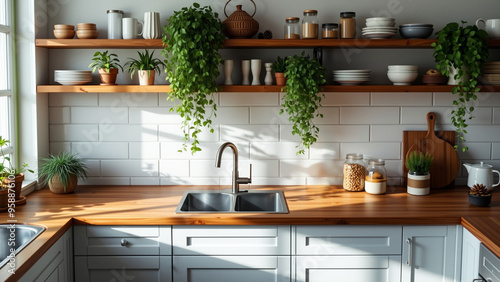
[74, 225, 172, 282]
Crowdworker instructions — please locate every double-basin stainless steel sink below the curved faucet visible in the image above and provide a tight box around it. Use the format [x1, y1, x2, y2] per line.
[175, 190, 288, 213]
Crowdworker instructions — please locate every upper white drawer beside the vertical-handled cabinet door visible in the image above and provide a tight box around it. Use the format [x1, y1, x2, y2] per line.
[295, 226, 402, 255]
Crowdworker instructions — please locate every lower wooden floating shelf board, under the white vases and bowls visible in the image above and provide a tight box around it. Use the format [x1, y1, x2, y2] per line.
[37, 85, 500, 93]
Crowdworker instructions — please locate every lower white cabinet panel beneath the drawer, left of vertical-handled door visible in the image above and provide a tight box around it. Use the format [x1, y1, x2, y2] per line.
[295, 256, 401, 282]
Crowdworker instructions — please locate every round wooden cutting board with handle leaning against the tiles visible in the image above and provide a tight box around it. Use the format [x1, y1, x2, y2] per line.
[405, 112, 460, 188]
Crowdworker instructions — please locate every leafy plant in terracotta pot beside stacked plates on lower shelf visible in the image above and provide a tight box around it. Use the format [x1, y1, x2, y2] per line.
[89, 51, 123, 85]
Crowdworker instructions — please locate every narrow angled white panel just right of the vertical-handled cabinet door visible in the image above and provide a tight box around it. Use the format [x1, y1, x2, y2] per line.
[461, 228, 481, 282]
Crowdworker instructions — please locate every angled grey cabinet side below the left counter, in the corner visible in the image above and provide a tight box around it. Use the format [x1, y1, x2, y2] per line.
[19, 229, 73, 282]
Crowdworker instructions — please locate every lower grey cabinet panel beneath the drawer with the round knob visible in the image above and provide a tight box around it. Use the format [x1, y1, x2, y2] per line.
[75, 256, 172, 282]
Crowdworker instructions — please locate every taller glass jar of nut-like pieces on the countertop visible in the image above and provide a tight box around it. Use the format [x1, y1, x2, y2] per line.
[342, 154, 366, 192]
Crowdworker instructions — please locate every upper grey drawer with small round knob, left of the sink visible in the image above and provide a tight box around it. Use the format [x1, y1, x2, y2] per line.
[74, 225, 172, 256]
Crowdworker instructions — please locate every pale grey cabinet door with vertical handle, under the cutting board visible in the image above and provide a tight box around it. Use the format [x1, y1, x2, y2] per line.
[401, 226, 462, 282]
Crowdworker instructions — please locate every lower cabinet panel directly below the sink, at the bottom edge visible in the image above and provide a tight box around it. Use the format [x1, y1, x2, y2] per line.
[173, 256, 291, 282]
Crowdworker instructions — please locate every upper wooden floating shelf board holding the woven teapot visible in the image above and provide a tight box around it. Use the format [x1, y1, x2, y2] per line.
[35, 38, 500, 49]
